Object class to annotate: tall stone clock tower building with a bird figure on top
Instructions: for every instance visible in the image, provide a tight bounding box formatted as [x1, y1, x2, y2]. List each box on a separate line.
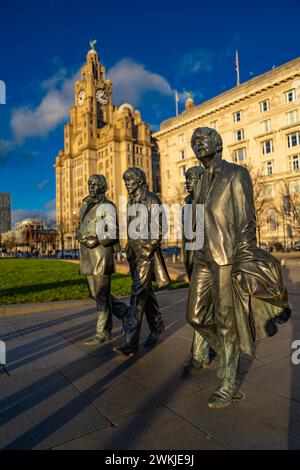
[55, 49, 160, 249]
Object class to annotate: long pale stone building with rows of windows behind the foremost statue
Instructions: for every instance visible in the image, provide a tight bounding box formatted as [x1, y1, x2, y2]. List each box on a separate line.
[154, 59, 300, 246]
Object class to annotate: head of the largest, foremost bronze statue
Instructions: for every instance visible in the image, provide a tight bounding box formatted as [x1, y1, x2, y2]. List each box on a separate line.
[191, 127, 223, 167]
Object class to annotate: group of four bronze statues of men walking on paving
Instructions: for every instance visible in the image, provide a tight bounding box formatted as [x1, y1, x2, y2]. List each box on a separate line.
[78, 127, 291, 408]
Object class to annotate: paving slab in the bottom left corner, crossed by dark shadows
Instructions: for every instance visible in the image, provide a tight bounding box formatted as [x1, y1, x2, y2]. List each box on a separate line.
[0, 368, 110, 449]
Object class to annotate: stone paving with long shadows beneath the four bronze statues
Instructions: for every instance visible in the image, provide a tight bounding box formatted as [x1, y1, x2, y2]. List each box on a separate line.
[0, 264, 300, 450]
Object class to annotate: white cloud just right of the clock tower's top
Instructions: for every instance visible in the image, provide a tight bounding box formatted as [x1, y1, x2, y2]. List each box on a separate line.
[107, 58, 174, 106]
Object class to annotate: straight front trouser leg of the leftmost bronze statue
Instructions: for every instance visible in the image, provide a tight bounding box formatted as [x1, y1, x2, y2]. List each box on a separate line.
[87, 274, 112, 337]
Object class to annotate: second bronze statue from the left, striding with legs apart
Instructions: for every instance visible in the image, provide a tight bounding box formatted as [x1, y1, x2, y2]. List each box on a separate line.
[114, 167, 170, 356]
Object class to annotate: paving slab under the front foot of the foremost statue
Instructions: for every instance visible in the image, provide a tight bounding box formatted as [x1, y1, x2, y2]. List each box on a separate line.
[167, 381, 300, 450]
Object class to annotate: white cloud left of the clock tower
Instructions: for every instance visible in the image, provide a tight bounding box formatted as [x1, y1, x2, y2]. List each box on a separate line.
[11, 69, 78, 144]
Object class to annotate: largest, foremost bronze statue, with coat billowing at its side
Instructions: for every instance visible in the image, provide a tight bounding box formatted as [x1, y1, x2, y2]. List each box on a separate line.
[187, 127, 290, 408]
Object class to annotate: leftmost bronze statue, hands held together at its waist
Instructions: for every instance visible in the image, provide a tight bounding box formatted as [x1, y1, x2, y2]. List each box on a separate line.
[78, 175, 128, 346]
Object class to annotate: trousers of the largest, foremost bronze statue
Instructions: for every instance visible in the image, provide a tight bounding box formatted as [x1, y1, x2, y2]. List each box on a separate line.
[187, 261, 239, 380]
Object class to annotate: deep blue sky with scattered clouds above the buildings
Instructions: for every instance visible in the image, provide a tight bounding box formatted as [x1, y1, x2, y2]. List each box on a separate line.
[0, 0, 300, 226]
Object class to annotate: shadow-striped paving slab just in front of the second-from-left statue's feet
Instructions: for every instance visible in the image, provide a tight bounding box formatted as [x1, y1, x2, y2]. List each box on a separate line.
[60, 353, 198, 423]
